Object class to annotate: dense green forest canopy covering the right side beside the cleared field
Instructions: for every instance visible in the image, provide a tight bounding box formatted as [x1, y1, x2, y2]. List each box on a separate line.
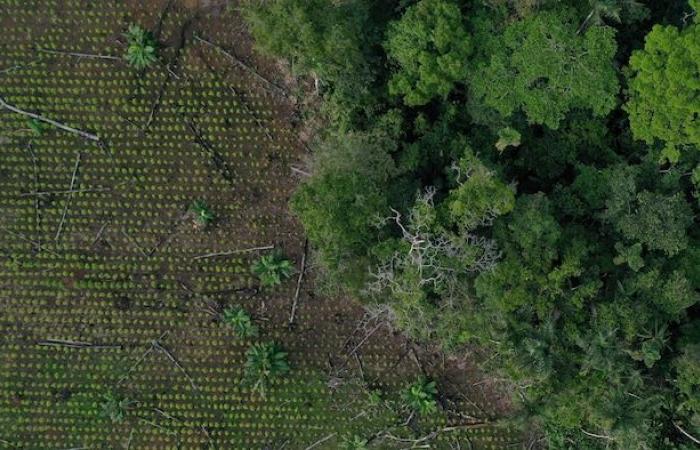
[245, 0, 700, 449]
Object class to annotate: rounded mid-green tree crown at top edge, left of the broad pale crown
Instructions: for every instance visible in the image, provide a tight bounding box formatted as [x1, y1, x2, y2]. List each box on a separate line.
[385, 0, 472, 106]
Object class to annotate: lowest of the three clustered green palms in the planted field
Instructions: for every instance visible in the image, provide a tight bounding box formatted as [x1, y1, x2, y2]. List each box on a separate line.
[244, 342, 289, 397]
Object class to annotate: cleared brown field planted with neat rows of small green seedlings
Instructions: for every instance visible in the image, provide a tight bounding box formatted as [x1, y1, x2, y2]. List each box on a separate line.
[0, 0, 517, 449]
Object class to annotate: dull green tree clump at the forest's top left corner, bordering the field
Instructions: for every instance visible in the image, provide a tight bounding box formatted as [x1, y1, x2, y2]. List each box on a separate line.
[243, 0, 386, 130]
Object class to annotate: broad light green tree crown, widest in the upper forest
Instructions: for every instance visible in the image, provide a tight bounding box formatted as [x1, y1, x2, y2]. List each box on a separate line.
[470, 10, 618, 129]
